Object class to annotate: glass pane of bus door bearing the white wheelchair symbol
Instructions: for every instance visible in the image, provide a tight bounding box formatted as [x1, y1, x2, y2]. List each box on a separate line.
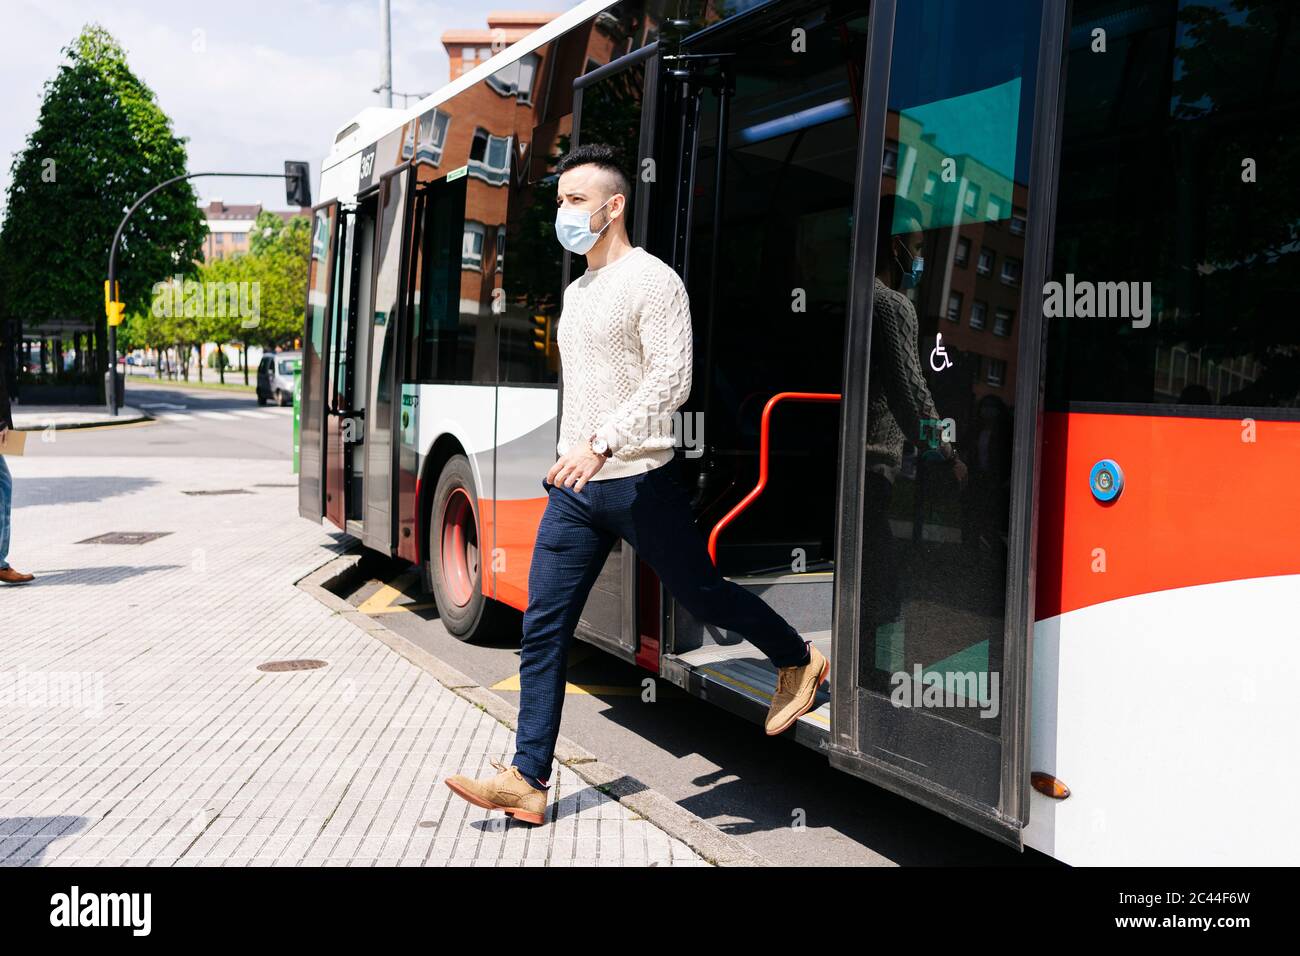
[857, 0, 1041, 754]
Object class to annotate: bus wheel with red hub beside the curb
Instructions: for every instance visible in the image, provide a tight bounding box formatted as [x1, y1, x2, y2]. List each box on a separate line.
[428, 455, 504, 643]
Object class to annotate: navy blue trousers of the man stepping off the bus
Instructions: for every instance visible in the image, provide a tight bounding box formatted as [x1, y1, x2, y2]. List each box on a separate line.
[512, 459, 809, 780]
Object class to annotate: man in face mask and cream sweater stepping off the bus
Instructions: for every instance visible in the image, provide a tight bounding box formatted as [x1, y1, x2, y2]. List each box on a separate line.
[446, 144, 831, 823]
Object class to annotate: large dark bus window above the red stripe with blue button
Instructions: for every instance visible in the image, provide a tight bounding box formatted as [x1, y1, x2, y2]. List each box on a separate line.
[1048, 0, 1300, 418]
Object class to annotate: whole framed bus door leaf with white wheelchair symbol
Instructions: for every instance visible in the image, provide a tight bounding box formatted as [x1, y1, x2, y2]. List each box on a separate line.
[827, 0, 1065, 847]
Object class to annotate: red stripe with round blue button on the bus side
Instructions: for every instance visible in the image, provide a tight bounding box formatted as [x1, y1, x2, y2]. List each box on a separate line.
[1035, 414, 1300, 620]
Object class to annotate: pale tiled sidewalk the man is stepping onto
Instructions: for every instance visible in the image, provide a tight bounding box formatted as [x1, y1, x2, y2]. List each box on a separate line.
[0, 457, 707, 866]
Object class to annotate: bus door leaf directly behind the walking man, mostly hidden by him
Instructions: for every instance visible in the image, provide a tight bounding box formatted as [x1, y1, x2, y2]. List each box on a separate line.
[555, 46, 655, 661]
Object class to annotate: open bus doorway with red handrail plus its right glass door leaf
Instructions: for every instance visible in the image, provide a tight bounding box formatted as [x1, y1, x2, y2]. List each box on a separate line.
[650, 0, 1065, 847]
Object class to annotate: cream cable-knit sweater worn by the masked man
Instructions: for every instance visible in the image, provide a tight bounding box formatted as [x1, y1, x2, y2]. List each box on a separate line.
[555, 246, 693, 481]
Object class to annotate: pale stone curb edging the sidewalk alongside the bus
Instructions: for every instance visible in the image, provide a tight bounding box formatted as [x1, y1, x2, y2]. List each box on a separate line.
[294, 553, 772, 866]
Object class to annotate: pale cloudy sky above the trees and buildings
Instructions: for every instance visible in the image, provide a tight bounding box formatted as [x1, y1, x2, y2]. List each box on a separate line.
[0, 0, 576, 215]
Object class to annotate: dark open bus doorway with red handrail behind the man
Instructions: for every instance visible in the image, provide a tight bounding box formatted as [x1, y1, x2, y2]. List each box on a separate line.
[647, 3, 868, 723]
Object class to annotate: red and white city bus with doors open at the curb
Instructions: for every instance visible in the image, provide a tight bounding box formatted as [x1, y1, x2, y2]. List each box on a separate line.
[299, 0, 1300, 865]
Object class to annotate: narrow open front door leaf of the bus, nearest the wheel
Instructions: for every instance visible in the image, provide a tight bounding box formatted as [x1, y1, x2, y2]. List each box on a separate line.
[354, 165, 411, 554]
